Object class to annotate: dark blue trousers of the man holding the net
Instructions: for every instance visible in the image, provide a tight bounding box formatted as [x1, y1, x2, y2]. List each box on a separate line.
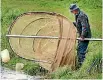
[77, 41, 89, 65]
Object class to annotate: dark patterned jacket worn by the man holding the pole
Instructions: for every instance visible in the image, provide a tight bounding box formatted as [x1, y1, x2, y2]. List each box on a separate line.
[74, 11, 91, 38]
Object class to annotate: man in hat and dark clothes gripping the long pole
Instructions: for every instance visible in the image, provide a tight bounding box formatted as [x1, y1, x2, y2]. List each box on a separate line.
[70, 4, 91, 67]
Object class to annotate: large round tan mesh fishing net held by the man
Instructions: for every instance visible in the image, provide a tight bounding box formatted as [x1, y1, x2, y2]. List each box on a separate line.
[8, 12, 76, 71]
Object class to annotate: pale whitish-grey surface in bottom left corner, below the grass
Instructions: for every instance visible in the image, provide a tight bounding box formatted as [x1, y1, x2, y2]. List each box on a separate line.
[0, 67, 41, 80]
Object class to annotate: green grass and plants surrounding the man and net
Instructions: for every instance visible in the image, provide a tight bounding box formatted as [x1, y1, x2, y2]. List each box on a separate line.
[1, 0, 102, 79]
